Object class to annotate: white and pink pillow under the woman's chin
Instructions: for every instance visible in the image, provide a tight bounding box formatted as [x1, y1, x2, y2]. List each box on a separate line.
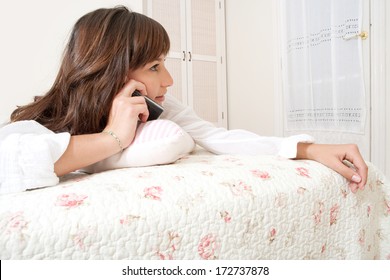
[83, 120, 195, 173]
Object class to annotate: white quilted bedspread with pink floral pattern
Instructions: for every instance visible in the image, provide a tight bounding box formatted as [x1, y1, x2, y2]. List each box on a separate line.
[0, 150, 390, 260]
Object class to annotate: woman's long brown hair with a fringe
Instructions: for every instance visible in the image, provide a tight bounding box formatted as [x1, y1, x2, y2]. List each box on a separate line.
[11, 6, 170, 135]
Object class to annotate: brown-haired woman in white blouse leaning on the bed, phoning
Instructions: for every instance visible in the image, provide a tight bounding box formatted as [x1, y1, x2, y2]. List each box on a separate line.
[0, 7, 367, 192]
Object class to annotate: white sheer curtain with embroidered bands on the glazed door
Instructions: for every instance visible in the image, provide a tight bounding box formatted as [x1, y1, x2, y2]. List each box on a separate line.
[280, 0, 366, 133]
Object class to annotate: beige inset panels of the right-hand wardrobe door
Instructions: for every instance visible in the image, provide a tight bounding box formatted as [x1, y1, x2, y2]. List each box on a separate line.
[187, 0, 219, 124]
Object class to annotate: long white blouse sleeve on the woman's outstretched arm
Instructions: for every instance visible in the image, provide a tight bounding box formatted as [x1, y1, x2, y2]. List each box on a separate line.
[161, 94, 314, 158]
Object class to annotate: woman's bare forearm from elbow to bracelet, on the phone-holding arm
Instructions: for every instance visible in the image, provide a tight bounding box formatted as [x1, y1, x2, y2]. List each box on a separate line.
[54, 133, 121, 176]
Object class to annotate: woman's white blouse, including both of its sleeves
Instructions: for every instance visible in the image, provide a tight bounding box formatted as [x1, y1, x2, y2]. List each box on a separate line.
[0, 94, 313, 194]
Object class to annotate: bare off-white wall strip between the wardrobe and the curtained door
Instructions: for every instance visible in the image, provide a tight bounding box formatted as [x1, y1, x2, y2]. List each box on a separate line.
[225, 0, 275, 135]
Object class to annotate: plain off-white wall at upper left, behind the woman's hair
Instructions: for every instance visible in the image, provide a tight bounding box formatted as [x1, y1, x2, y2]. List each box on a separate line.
[0, 0, 142, 123]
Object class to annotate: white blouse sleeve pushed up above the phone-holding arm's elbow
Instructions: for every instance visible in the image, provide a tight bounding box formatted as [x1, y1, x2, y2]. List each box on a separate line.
[0, 121, 70, 194]
